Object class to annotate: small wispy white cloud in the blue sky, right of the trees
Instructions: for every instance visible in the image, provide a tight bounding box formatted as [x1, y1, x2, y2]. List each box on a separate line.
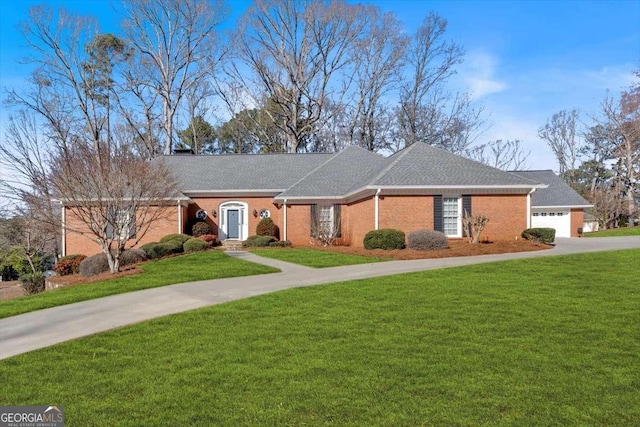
[460, 51, 507, 100]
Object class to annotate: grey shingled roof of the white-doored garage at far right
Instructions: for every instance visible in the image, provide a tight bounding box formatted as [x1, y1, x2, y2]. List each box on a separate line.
[512, 170, 593, 208]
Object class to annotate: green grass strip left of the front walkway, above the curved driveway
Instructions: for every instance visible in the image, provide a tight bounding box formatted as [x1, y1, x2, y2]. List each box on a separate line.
[0, 251, 279, 318]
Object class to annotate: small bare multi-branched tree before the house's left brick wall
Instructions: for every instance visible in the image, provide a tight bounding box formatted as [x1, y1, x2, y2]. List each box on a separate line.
[49, 145, 177, 273]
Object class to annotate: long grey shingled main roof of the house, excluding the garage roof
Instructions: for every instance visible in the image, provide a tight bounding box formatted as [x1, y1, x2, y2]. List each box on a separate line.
[160, 143, 542, 200]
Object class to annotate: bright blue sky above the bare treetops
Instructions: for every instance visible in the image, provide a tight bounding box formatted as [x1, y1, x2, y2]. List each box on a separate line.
[0, 0, 640, 170]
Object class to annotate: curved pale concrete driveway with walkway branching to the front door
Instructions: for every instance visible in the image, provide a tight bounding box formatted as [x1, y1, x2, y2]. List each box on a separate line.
[0, 236, 640, 359]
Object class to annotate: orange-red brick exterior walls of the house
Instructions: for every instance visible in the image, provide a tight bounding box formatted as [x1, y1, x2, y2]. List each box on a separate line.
[65, 194, 536, 255]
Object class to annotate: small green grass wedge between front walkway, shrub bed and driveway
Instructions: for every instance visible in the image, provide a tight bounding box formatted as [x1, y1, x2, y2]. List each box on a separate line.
[251, 248, 390, 268]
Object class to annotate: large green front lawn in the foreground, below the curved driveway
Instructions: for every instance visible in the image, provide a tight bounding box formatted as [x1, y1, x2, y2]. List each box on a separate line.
[0, 250, 640, 426]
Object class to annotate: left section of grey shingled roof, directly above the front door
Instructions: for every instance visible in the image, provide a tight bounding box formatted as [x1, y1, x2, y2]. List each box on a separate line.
[160, 153, 334, 195]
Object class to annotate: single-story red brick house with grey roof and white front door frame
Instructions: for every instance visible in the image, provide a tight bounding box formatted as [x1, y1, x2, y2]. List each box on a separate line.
[63, 143, 588, 255]
